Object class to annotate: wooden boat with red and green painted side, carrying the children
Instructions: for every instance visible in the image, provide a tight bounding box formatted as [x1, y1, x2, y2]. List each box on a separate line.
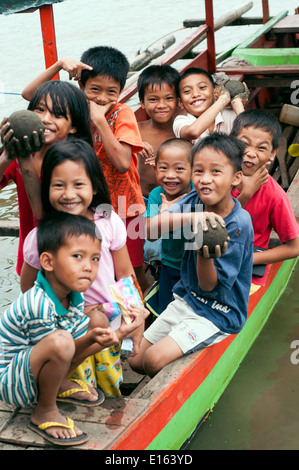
[0, 0, 299, 450]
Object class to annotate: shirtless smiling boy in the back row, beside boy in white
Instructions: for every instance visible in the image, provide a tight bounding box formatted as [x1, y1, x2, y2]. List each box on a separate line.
[137, 64, 180, 198]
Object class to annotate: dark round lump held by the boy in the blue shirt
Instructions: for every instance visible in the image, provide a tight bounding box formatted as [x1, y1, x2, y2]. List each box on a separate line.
[195, 219, 228, 258]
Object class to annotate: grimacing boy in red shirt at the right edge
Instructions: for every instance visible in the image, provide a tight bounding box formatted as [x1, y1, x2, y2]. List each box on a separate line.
[232, 109, 299, 293]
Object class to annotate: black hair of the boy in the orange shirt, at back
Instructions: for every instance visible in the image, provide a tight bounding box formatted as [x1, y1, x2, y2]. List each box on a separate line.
[80, 46, 130, 91]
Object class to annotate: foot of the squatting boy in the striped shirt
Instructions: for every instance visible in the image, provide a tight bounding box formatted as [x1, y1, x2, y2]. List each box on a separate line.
[31, 404, 83, 439]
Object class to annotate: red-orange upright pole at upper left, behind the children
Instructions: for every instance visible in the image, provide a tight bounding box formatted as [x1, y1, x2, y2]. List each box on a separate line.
[39, 5, 59, 80]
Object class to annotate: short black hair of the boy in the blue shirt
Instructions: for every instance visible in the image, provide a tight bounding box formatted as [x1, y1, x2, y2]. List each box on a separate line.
[191, 132, 246, 172]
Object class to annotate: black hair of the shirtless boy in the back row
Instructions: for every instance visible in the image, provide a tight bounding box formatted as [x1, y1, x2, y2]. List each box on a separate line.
[137, 64, 180, 101]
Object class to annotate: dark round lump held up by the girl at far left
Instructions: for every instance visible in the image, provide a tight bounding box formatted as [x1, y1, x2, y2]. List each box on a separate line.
[8, 110, 45, 153]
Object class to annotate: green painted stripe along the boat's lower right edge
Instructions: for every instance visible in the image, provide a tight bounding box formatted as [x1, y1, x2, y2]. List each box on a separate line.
[147, 258, 298, 450]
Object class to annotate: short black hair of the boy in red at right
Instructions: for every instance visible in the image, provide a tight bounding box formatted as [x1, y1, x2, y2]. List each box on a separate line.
[231, 109, 281, 150]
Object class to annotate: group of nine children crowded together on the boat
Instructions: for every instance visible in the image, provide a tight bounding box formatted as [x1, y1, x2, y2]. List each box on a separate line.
[0, 46, 299, 445]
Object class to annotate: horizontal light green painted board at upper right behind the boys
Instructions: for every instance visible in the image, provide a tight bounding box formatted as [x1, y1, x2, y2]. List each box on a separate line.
[232, 47, 299, 65]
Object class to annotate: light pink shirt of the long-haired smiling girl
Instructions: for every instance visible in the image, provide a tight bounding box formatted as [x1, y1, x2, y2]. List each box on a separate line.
[24, 211, 127, 305]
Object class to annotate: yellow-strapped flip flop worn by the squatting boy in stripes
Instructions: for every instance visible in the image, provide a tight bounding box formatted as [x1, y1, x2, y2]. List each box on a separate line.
[28, 416, 88, 446]
